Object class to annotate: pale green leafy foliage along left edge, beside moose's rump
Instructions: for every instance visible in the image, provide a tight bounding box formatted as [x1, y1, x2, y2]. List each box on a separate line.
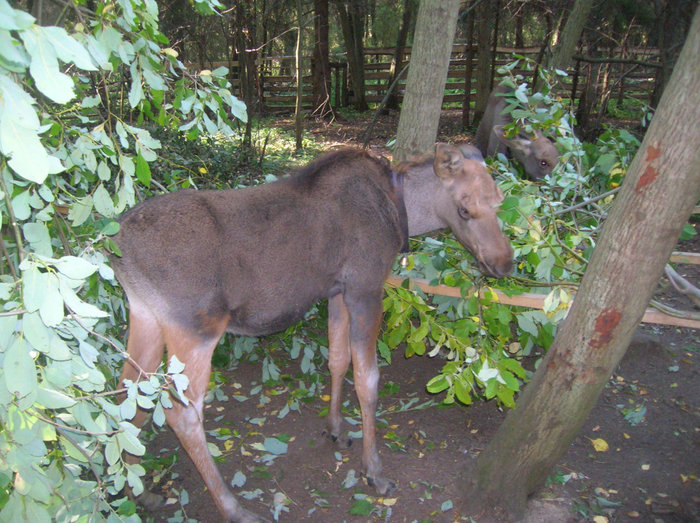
[0, 0, 246, 522]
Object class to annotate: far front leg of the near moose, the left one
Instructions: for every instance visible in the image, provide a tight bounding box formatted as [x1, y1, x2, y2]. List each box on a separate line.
[327, 294, 352, 448]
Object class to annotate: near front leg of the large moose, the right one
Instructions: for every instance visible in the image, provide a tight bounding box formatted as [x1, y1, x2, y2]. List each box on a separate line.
[346, 289, 396, 495]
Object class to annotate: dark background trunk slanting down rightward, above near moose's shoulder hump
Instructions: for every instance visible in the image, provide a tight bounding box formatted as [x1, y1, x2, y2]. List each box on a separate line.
[335, 0, 367, 111]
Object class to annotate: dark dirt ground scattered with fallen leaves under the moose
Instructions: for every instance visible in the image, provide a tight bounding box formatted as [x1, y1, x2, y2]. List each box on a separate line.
[138, 114, 700, 523]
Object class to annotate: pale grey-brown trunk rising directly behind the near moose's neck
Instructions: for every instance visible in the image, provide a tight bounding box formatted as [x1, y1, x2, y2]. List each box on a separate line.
[394, 0, 460, 161]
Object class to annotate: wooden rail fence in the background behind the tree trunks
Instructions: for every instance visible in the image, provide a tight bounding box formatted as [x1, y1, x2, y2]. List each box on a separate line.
[200, 44, 658, 112]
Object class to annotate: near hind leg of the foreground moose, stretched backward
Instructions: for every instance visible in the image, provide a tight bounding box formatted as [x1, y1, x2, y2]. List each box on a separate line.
[165, 323, 265, 523]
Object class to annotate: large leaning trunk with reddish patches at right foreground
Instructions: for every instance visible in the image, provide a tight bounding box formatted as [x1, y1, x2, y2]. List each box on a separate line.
[460, 7, 700, 522]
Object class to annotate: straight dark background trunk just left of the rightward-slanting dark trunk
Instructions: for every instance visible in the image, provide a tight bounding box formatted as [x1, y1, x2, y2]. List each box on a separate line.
[311, 0, 333, 116]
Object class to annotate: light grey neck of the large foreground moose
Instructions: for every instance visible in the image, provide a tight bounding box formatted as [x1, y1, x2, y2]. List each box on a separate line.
[404, 164, 447, 236]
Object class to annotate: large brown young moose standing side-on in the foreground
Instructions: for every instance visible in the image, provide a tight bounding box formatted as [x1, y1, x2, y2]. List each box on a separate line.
[112, 144, 513, 522]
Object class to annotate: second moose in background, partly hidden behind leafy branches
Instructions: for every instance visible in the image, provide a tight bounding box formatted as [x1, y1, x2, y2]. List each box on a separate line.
[476, 85, 559, 180]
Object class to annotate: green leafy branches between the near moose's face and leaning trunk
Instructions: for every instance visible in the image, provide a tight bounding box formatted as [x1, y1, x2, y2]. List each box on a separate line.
[380, 57, 640, 407]
